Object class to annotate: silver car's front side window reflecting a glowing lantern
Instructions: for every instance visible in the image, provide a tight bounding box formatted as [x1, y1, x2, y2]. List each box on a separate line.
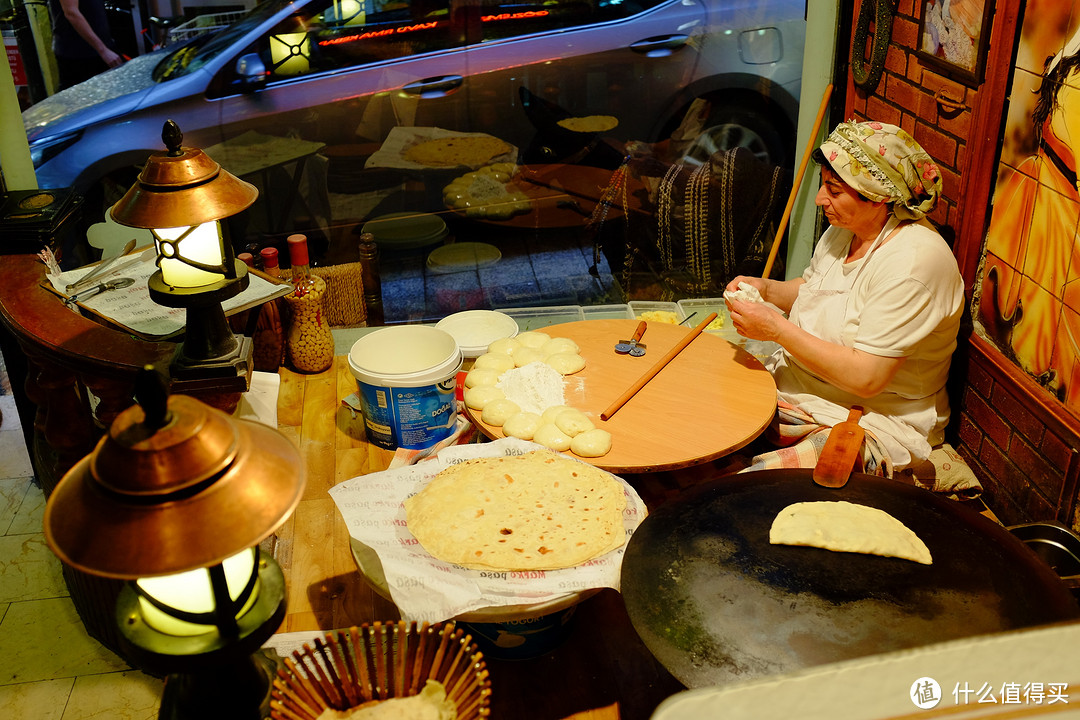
[256, 0, 465, 82]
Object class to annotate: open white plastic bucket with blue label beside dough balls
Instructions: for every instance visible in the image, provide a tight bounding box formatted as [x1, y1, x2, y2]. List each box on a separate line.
[349, 325, 461, 450]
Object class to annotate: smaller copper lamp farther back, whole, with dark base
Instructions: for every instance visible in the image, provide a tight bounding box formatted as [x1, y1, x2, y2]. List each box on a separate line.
[109, 120, 258, 388]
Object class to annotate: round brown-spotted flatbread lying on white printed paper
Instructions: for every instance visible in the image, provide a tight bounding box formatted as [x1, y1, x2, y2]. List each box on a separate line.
[405, 450, 626, 571]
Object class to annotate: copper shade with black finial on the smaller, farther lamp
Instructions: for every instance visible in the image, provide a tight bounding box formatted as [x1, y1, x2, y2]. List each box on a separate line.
[109, 120, 259, 229]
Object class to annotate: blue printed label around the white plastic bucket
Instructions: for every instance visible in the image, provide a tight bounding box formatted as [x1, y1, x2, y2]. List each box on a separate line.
[359, 377, 458, 450]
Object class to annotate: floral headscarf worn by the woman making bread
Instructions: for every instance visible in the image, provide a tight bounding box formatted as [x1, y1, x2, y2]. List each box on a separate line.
[813, 121, 942, 220]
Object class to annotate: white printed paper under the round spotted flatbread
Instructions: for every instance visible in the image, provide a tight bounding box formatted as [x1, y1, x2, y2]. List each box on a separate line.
[329, 437, 647, 623]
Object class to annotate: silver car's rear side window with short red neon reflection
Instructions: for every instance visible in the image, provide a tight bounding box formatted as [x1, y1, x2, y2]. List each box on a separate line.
[481, 0, 663, 41]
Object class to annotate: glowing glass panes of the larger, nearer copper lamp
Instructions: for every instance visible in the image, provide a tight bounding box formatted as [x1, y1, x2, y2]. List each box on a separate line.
[135, 548, 259, 637]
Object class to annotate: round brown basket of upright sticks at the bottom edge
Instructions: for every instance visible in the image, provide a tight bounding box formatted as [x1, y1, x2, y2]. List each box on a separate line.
[270, 621, 491, 720]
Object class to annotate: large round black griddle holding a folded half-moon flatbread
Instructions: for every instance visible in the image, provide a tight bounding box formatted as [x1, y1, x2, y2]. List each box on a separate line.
[622, 470, 1080, 688]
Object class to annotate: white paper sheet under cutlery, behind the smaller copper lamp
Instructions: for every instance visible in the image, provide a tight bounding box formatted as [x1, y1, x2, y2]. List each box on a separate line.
[46, 245, 293, 340]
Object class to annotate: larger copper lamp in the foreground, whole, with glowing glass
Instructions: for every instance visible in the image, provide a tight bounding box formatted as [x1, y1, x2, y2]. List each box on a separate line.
[44, 367, 305, 720]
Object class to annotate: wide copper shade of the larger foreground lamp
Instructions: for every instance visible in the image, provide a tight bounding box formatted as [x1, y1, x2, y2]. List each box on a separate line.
[44, 371, 305, 580]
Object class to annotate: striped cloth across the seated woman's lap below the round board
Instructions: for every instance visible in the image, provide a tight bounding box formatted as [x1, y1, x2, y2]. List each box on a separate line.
[739, 400, 892, 477]
